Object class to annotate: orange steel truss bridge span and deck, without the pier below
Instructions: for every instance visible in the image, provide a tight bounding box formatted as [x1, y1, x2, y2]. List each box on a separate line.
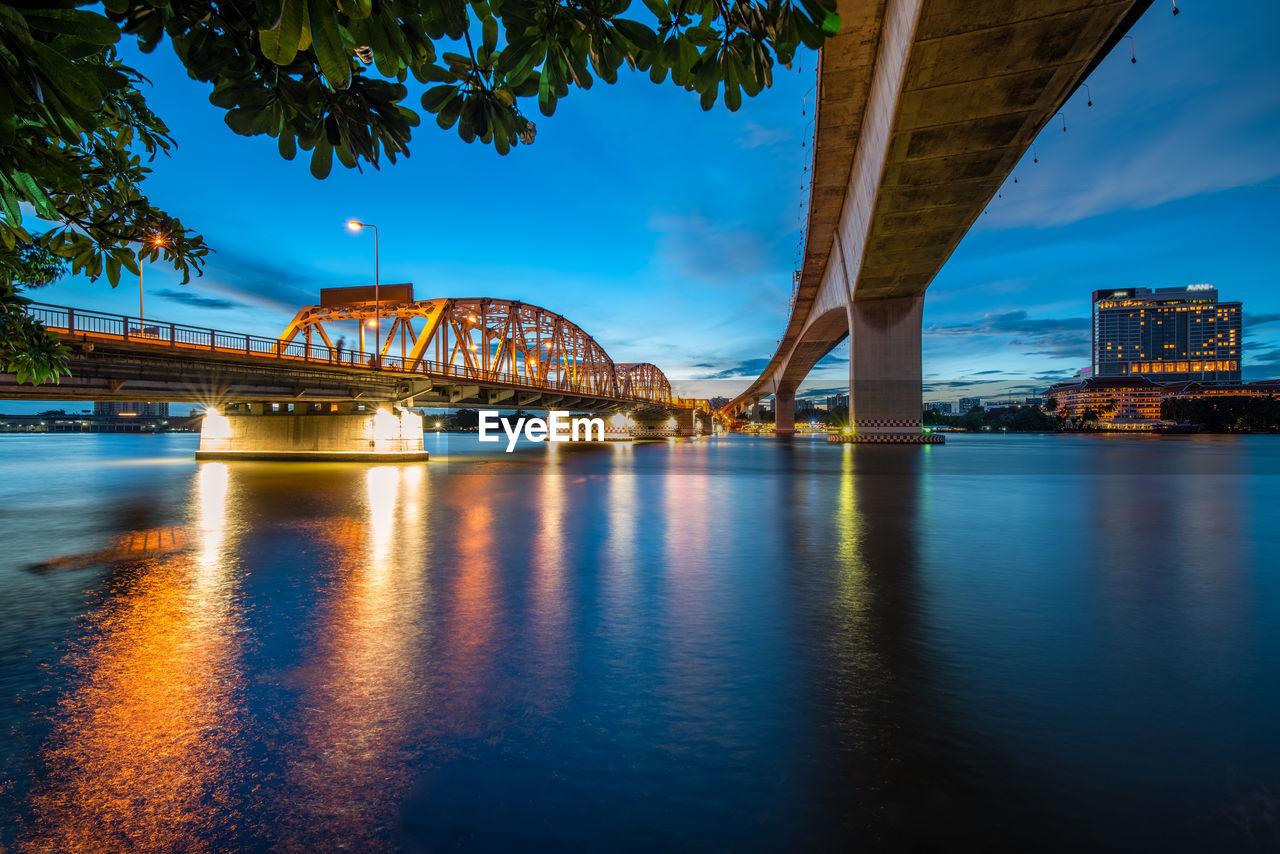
[0, 297, 710, 421]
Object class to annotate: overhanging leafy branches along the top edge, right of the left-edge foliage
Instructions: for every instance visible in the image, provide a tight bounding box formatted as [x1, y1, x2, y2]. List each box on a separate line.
[104, 0, 840, 171]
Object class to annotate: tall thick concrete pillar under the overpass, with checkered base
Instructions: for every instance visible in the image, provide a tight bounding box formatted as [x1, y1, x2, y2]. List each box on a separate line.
[828, 294, 943, 444]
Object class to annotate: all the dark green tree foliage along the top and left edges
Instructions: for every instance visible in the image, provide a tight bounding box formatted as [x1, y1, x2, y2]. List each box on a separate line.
[0, 0, 840, 382]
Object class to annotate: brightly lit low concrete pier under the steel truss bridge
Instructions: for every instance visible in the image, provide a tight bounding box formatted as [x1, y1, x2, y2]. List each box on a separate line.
[196, 405, 428, 462]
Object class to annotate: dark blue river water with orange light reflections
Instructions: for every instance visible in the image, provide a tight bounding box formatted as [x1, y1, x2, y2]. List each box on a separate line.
[0, 435, 1280, 851]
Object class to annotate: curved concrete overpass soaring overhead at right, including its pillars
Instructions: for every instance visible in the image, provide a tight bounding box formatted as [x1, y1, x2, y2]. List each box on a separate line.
[724, 0, 1151, 442]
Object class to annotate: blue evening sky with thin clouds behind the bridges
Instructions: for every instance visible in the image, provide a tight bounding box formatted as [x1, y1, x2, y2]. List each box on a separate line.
[4, 0, 1280, 411]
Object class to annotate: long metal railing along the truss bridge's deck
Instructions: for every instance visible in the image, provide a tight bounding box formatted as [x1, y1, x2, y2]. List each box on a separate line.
[27, 302, 690, 406]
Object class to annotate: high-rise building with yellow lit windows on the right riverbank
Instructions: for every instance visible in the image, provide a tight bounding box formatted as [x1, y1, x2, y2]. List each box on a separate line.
[1093, 284, 1242, 383]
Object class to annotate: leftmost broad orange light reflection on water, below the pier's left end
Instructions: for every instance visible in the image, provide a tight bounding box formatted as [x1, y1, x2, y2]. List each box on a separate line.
[27, 463, 244, 851]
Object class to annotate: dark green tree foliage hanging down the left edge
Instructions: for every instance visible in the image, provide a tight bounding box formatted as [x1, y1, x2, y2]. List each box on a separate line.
[0, 0, 207, 383]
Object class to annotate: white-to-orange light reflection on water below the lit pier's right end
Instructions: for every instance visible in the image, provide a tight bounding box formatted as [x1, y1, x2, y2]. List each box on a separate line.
[280, 466, 434, 850]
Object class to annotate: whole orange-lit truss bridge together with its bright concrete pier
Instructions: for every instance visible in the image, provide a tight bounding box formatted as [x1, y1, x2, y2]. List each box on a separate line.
[0, 299, 714, 458]
